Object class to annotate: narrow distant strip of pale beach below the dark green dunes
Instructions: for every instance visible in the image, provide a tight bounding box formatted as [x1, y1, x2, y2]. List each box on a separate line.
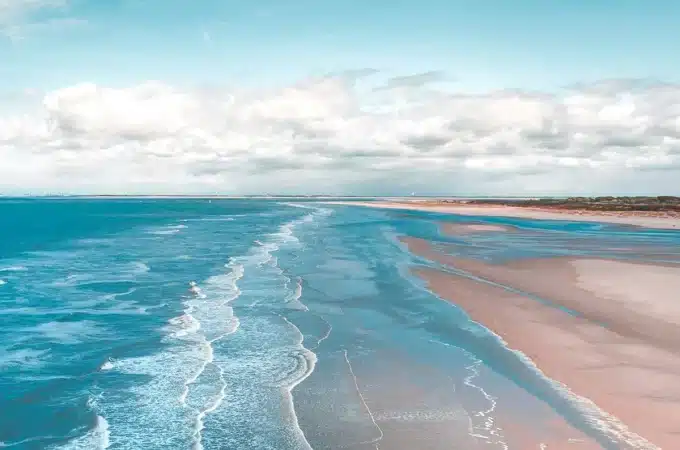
[327, 201, 680, 230]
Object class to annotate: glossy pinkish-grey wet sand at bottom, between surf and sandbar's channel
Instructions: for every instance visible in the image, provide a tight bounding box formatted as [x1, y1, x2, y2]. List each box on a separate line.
[295, 342, 601, 450]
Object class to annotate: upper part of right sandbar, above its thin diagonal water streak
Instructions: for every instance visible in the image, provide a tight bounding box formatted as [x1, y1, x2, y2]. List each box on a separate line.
[408, 239, 680, 352]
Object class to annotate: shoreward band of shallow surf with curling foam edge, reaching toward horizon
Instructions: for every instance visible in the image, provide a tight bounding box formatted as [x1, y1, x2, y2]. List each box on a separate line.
[193, 209, 325, 449]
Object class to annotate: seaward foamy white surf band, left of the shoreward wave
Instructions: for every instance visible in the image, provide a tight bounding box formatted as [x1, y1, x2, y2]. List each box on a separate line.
[93, 261, 244, 450]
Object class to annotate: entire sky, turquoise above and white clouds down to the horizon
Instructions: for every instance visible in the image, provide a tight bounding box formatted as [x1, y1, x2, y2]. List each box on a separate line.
[0, 0, 680, 195]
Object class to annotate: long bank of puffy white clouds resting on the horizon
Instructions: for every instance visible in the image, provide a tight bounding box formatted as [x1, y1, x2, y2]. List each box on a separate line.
[0, 73, 680, 194]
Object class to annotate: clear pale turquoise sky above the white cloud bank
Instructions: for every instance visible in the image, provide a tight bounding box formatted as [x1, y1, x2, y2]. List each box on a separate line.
[0, 0, 680, 90]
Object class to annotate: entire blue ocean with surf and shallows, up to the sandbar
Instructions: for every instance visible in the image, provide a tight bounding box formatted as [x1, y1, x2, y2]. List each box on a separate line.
[0, 198, 676, 450]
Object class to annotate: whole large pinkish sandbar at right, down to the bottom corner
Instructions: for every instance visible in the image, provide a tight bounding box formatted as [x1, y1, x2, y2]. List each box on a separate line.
[404, 239, 680, 449]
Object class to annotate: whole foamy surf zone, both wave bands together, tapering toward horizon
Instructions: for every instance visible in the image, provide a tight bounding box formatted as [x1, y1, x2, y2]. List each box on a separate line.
[82, 205, 330, 450]
